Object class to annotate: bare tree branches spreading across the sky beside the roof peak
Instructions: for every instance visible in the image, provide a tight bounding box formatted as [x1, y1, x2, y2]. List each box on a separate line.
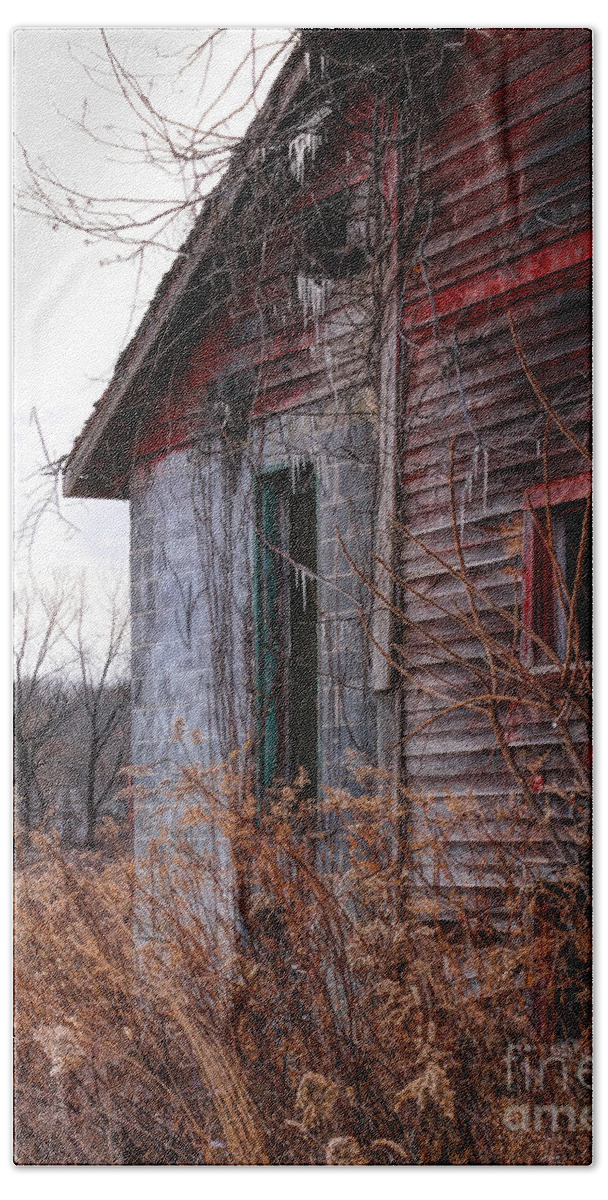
[18, 29, 297, 258]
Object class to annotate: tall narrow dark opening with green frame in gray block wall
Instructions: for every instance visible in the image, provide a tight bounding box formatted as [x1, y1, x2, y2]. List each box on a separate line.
[255, 464, 318, 799]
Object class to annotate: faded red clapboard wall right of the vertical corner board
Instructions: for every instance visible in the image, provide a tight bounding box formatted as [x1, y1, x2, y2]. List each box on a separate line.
[395, 30, 590, 882]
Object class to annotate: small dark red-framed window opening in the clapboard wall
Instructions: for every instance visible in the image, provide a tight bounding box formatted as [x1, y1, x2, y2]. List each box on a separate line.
[524, 480, 591, 662]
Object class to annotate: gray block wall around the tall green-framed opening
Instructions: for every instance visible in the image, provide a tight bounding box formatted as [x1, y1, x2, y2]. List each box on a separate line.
[131, 389, 395, 912]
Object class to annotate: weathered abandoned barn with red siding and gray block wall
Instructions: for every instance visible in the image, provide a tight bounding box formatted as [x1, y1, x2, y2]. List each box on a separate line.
[65, 29, 591, 907]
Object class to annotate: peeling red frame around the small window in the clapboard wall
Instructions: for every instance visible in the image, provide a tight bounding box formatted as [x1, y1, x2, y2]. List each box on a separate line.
[522, 472, 591, 666]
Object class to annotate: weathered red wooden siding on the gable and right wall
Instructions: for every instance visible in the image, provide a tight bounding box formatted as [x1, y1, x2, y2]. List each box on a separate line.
[67, 30, 591, 892]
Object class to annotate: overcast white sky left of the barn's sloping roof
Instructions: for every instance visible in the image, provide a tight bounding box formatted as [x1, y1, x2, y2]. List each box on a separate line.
[14, 28, 288, 628]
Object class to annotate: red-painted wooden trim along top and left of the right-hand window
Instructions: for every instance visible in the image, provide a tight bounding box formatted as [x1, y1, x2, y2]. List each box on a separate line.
[520, 472, 591, 671]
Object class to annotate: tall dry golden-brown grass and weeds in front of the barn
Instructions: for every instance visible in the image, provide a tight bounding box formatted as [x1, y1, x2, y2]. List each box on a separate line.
[16, 758, 590, 1164]
